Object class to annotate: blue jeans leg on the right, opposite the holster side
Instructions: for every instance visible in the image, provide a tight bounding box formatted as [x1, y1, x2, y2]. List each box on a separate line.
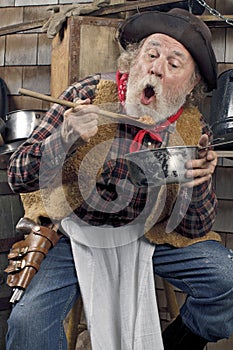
[153, 241, 233, 342]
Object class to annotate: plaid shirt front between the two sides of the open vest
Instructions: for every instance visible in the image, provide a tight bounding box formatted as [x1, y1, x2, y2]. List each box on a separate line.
[73, 124, 149, 227]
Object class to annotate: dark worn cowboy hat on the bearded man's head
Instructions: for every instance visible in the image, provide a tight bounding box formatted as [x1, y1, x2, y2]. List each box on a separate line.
[118, 8, 217, 91]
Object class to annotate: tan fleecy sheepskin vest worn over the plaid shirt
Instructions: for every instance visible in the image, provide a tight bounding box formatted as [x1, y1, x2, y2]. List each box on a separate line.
[21, 80, 220, 247]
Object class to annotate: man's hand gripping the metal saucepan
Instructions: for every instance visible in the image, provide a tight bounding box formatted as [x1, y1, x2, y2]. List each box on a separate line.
[185, 135, 217, 187]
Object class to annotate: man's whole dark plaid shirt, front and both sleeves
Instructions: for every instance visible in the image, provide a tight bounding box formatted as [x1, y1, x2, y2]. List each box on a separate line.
[8, 74, 216, 238]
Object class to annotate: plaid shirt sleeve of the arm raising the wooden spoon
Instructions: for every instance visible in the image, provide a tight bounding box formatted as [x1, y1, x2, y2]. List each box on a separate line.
[8, 74, 100, 193]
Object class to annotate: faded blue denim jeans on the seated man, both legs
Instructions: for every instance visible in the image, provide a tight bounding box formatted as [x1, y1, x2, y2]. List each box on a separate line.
[7, 237, 233, 350]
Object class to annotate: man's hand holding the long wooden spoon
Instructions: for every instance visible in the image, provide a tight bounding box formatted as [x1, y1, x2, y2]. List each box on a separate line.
[61, 99, 98, 148]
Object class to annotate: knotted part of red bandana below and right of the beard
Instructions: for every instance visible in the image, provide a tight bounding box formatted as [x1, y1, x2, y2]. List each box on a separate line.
[130, 107, 183, 152]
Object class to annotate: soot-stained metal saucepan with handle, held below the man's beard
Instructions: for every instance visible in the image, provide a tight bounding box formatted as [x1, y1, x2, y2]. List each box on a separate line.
[125, 140, 233, 187]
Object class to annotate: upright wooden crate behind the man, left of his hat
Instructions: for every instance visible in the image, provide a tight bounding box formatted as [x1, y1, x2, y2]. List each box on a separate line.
[51, 16, 121, 96]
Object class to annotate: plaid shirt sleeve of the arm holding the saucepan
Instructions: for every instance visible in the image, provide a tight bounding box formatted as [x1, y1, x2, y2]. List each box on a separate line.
[176, 115, 217, 238]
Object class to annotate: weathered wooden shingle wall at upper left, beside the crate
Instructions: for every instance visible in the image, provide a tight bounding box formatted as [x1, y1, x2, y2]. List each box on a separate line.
[0, 0, 90, 111]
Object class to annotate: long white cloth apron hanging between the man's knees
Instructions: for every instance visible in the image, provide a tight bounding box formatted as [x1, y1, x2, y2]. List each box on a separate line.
[62, 218, 163, 350]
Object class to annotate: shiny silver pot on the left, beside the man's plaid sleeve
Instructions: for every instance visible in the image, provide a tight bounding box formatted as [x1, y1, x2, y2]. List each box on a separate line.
[4, 110, 46, 143]
